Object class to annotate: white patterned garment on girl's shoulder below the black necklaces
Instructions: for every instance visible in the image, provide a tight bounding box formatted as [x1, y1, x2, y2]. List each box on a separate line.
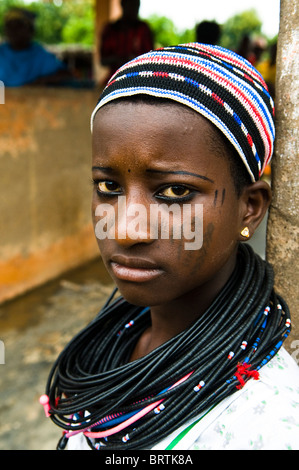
[68, 348, 299, 450]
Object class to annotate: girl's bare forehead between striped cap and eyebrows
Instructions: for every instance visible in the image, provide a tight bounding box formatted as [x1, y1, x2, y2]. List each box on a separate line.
[92, 99, 231, 171]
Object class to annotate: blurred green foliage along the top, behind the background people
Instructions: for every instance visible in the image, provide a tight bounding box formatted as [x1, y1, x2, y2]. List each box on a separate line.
[0, 0, 270, 49]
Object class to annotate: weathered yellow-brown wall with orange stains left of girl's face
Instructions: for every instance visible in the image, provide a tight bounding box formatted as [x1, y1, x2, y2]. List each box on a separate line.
[0, 87, 99, 302]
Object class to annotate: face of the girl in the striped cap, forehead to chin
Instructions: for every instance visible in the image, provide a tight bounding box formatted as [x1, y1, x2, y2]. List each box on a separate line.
[92, 102, 243, 309]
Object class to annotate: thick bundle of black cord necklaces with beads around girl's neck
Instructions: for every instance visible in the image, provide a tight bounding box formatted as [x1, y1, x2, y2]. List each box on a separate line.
[46, 245, 290, 450]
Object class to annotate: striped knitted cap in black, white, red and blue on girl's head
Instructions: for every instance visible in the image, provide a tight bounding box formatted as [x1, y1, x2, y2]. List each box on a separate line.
[91, 43, 275, 181]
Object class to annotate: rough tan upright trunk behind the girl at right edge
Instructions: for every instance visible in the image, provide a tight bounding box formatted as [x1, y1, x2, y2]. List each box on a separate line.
[266, 0, 299, 356]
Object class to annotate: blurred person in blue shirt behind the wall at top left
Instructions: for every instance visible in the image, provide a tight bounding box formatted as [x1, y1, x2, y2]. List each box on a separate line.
[0, 8, 70, 87]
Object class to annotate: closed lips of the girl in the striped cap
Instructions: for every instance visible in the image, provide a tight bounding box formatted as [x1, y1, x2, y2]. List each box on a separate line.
[110, 255, 163, 282]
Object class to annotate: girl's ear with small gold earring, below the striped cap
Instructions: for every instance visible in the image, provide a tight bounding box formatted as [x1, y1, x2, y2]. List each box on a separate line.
[240, 180, 272, 241]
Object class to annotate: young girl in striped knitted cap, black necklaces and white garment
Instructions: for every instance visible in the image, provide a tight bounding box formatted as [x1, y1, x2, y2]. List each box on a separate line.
[43, 43, 299, 450]
